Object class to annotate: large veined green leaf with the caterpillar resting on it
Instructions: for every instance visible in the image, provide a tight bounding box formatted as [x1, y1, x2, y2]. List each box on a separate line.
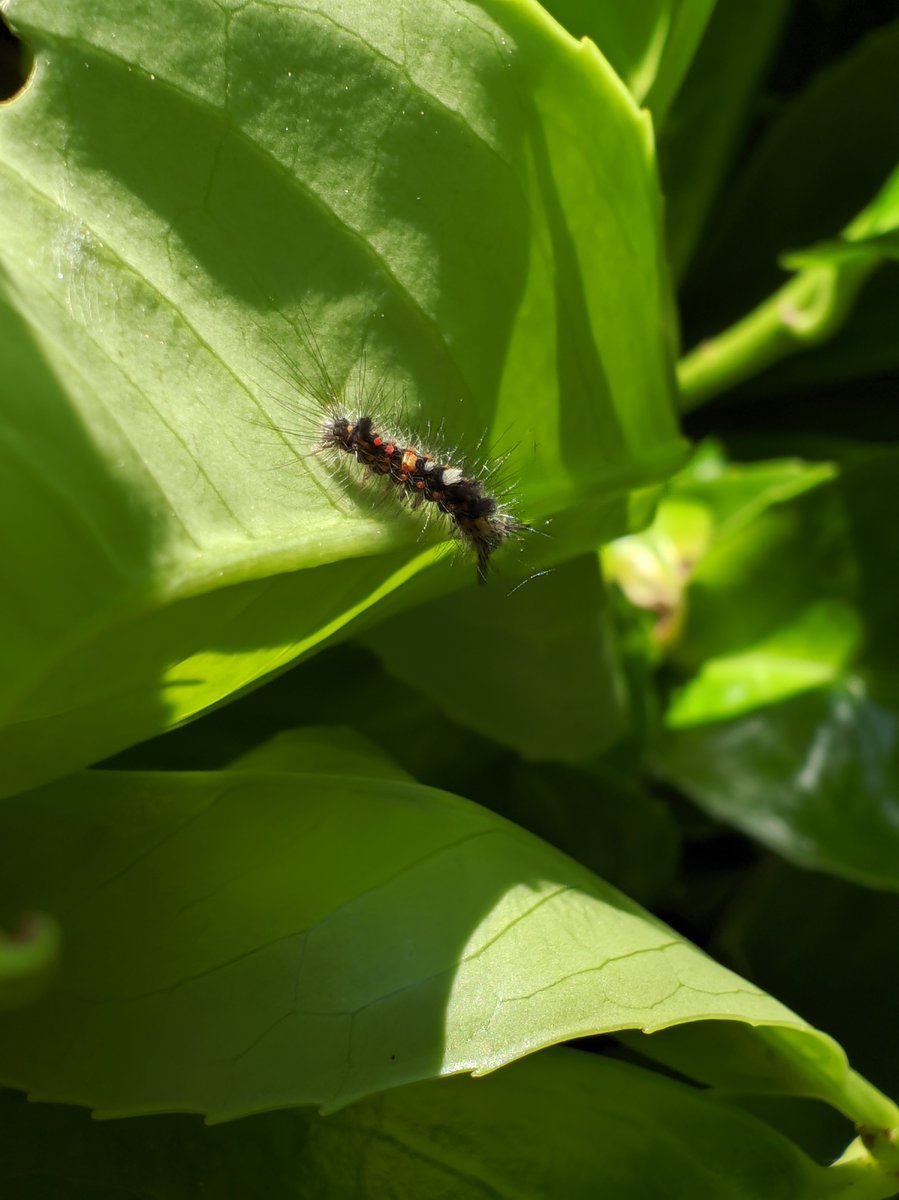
[0, 0, 679, 791]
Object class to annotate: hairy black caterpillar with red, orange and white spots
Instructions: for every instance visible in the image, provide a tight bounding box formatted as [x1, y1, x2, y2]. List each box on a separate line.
[262, 314, 534, 584]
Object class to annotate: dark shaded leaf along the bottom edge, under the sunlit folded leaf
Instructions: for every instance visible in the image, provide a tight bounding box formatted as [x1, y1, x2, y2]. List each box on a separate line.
[0, 1050, 893, 1200]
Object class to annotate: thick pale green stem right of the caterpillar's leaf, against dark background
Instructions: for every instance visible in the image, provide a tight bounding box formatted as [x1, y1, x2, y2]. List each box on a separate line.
[677, 257, 877, 413]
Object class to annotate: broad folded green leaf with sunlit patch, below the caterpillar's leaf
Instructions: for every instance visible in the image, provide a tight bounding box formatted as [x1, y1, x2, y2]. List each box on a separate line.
[0, 762, 889, 1123]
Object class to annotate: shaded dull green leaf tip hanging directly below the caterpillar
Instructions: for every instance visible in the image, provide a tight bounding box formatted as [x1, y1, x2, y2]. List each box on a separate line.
[367, 554, 628, 762]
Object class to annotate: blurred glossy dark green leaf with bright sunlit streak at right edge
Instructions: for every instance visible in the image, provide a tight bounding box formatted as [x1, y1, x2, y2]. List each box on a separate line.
[654, 450, 899, 888]
